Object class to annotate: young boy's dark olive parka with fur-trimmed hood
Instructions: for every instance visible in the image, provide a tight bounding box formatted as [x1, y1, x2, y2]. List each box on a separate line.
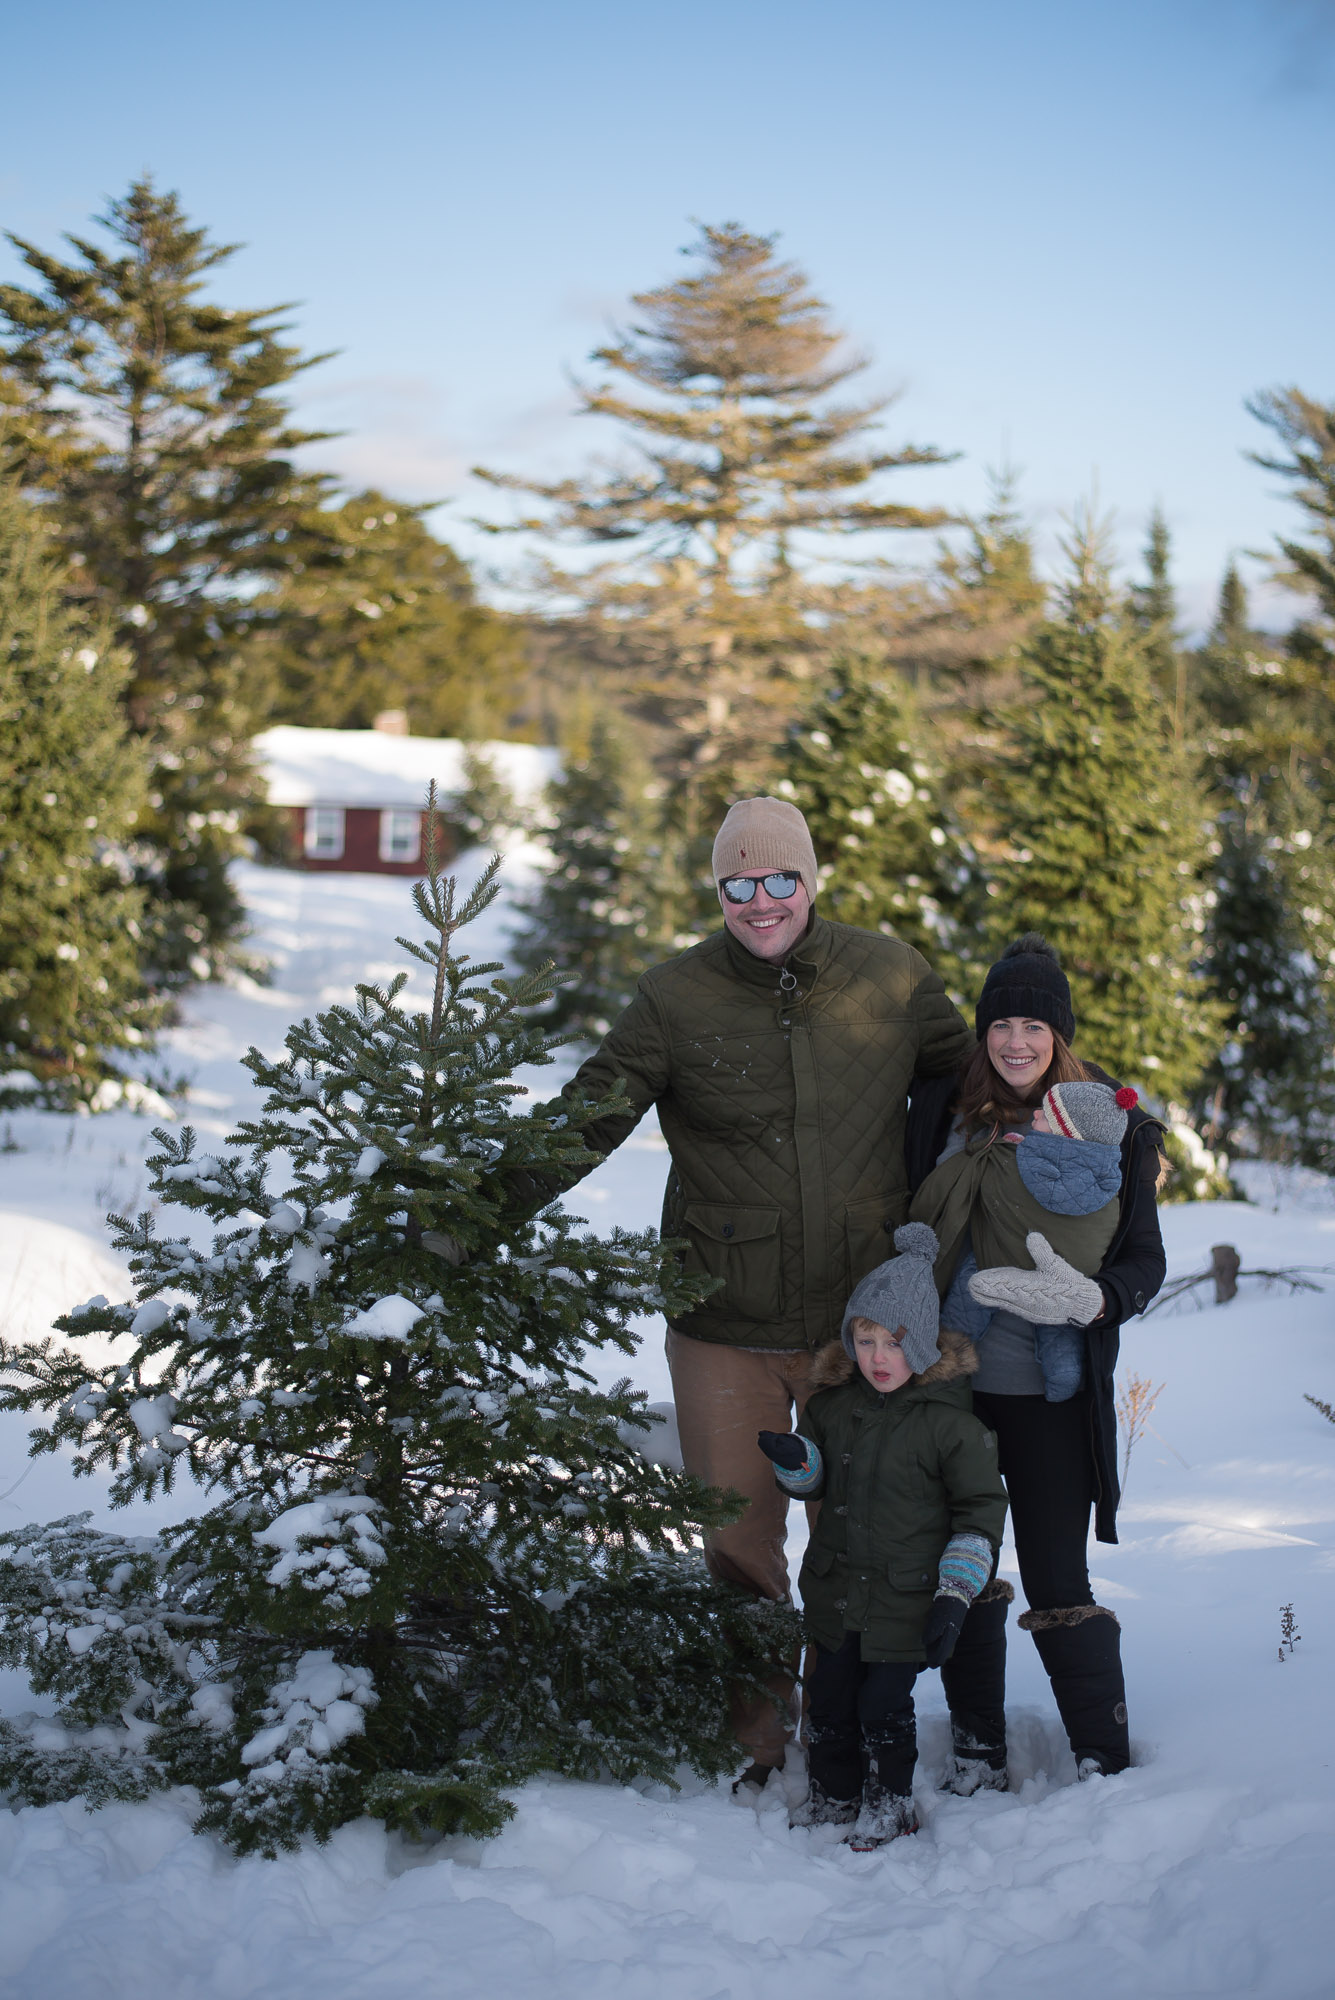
[797, 1328, 1005, 1666]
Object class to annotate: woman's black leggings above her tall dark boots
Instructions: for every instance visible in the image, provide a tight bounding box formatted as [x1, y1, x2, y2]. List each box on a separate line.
[973, 1390, 1093, 1612]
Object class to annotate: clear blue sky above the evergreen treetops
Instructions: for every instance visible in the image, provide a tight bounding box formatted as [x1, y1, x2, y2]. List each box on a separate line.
[0, 0, 1335, 620]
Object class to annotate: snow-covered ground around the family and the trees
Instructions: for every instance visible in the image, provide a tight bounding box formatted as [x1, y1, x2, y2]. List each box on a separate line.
[0, 854, 1335, 2000]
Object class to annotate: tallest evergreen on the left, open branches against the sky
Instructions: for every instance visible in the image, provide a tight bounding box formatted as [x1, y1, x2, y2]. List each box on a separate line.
[0, 178, 333, 980]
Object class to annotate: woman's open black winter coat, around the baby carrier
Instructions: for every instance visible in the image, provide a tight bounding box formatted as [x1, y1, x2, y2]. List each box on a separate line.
[903, 1062, 1167, 1542]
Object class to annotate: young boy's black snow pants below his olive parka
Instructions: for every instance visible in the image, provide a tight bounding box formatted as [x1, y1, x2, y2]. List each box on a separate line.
[805, 1632, 917, 1800]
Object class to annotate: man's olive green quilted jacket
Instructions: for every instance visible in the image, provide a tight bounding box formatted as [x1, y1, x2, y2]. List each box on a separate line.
[547, 916, 973, 1350]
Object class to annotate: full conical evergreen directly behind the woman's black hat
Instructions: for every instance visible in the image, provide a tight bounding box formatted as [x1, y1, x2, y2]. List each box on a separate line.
[989, 498, 1221, 1102]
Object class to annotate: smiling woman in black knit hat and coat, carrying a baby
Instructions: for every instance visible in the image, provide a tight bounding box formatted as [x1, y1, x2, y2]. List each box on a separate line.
[905, 932, 1165, 1794]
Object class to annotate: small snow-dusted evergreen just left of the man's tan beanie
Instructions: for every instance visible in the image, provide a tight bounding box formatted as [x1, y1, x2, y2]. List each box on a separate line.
[516, 716, 679, 1038]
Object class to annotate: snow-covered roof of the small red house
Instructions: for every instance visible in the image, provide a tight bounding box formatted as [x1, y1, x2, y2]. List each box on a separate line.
[256, 724, 560, 806]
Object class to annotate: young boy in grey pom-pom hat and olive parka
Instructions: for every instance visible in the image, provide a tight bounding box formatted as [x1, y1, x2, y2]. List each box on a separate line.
[759, 1222, 1005, 1852]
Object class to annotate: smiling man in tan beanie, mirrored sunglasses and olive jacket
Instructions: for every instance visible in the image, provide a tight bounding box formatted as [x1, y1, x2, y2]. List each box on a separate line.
[543, 798, 973, 1784]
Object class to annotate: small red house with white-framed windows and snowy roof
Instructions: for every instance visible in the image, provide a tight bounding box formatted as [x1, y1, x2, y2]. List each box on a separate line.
[256, 718, 560, 876]
